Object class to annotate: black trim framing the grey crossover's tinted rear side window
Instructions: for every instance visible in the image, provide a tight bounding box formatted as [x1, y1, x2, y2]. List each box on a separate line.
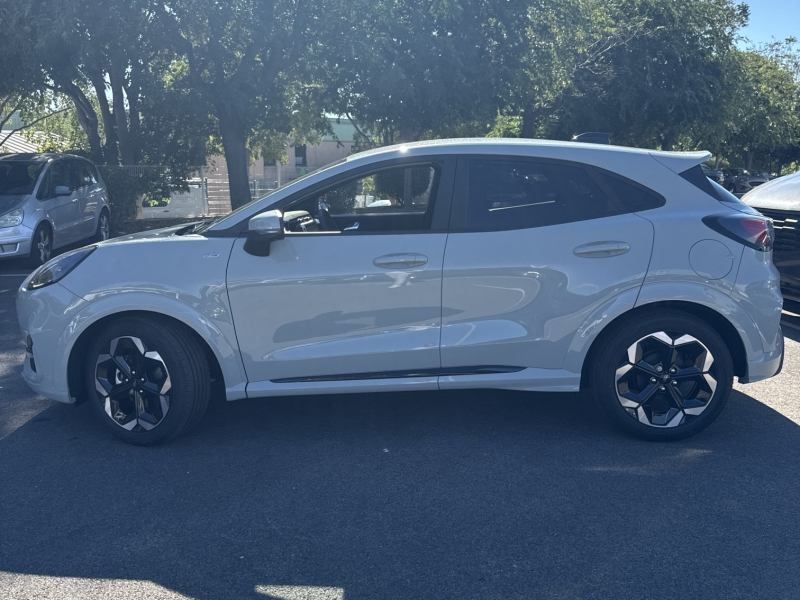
[449, 154, 648, 233]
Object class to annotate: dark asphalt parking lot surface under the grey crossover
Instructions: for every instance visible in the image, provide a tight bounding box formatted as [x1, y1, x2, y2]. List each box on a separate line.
[0, 263, 800, 600]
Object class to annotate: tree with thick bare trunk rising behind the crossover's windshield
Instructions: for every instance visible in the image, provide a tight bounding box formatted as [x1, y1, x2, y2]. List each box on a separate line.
[151, 0, 336, 208]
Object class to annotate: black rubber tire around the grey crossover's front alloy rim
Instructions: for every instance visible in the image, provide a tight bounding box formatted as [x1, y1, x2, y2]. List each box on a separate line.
[84, 317, 208, 446]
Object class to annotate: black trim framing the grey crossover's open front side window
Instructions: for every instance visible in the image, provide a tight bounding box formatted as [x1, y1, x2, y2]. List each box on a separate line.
[208, 154, 457, 237]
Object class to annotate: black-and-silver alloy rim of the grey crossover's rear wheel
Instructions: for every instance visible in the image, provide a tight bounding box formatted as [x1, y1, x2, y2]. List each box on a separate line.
[615, 331, 718, 427]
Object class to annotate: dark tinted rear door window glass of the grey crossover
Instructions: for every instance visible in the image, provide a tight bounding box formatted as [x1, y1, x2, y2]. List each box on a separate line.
[466, 159, 624, 231]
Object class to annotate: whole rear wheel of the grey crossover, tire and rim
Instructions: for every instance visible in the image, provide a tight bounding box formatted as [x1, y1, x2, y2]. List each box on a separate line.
[590, 310, 733, 441]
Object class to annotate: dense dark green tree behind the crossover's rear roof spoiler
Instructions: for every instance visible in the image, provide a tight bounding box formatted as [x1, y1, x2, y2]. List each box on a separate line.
[557, 0, 748, 150]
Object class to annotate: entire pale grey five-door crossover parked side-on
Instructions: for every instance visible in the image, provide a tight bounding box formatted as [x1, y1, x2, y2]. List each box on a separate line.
[17, 139, 783, 445]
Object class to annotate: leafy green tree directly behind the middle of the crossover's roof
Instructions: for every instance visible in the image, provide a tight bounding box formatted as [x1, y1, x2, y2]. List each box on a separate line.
[329, 0, 500, 144]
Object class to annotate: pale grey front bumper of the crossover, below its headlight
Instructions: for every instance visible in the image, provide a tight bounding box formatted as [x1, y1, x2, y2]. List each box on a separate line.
[17, 277, 88, 402]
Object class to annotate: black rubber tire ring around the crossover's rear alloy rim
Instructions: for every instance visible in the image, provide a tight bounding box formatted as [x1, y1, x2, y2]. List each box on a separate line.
[591, 311, 733, 441]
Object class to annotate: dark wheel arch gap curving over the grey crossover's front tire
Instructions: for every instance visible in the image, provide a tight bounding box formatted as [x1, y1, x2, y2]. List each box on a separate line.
[67, 310, 233, 405]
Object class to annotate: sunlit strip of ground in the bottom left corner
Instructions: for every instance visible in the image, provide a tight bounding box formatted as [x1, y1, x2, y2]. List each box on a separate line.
[0, 571, 194, 600]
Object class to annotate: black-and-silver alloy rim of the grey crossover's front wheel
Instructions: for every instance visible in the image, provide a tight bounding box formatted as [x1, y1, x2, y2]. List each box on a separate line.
[95, 336, 172, 431]
